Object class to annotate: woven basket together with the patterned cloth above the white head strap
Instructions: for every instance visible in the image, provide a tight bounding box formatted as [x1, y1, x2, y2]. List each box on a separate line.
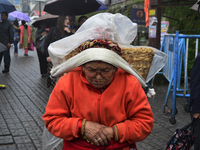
[65, 39, 155, 79]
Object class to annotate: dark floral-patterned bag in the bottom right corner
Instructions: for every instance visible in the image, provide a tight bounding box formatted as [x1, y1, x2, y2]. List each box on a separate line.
[166, 129, 194, 150]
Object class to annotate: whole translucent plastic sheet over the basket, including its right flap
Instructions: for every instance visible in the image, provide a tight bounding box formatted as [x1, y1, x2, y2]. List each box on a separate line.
[48, 13, 167, 86]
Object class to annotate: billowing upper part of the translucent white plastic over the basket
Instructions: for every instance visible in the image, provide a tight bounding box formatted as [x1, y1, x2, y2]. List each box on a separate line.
[48, 13, 137, 67]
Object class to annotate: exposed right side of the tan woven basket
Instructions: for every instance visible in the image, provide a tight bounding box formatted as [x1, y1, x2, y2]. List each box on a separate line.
[121, 47, 155, 80]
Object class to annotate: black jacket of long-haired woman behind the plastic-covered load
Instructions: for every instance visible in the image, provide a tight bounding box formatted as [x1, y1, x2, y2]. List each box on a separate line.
[44, 27, 73, 57]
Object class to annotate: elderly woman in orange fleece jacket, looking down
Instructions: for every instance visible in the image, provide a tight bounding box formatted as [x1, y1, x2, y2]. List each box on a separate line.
[43, 40, 154, 150]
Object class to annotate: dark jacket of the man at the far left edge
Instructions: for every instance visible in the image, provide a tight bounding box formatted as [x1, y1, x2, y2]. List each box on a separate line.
[0, 20, 14, 47]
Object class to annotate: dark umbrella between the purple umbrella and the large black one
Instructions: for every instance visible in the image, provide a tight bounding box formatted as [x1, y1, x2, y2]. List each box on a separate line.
[32, 14, 58, 28]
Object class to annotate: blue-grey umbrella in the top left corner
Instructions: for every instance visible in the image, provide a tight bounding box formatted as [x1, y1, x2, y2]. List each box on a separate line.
[0, 0, 16, 13]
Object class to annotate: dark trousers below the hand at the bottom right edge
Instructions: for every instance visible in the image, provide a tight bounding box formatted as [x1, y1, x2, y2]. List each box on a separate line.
[193, 118, 200, 150]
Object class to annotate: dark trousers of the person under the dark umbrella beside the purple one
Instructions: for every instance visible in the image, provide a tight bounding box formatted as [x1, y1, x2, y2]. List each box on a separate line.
[37, 49, 47, 74]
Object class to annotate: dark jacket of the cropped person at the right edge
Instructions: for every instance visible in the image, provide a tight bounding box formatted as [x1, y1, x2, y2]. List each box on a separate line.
[188, 53, 200, 113]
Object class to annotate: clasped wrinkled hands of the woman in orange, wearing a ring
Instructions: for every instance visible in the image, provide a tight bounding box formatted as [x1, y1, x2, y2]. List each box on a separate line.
[85, 121, 113, 146]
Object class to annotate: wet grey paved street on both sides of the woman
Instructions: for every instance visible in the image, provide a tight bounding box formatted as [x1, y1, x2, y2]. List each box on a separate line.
[0, 47, 193, 150]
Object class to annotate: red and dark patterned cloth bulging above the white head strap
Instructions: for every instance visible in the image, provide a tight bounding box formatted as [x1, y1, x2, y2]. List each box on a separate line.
[77, 39, 122, 55]
